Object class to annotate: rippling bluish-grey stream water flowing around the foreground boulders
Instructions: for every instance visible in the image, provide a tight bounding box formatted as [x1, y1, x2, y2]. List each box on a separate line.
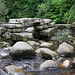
[0, 49, 75, 75]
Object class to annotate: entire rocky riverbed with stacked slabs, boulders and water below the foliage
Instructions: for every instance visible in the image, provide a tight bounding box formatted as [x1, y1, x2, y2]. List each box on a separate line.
[0, 18, 75, 75]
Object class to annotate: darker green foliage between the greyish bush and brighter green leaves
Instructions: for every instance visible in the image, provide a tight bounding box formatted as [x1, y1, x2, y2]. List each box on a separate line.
[7, 0, 42, 19]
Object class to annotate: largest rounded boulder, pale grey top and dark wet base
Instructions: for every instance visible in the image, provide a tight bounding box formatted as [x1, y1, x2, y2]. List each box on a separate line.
[10, 41, 36, 58]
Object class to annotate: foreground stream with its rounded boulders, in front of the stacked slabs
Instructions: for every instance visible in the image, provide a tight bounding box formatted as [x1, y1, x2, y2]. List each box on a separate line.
[0, 41, 75, 75]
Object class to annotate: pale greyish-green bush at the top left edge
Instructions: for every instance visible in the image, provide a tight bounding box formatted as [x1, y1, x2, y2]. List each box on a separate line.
[0, 0, 8, 23]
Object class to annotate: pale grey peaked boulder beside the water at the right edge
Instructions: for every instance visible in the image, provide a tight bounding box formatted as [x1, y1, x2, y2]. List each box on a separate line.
[57, 42, 74, 56]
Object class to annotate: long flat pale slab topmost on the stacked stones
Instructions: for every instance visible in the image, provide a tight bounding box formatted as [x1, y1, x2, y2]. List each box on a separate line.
[9, 18, 44, 27]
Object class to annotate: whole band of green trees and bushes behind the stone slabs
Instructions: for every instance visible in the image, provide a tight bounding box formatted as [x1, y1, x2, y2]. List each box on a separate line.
[0, 0, 75, 23]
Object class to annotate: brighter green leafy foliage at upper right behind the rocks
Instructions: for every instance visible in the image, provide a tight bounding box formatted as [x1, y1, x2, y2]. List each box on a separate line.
[36, 0, 75, 23]
